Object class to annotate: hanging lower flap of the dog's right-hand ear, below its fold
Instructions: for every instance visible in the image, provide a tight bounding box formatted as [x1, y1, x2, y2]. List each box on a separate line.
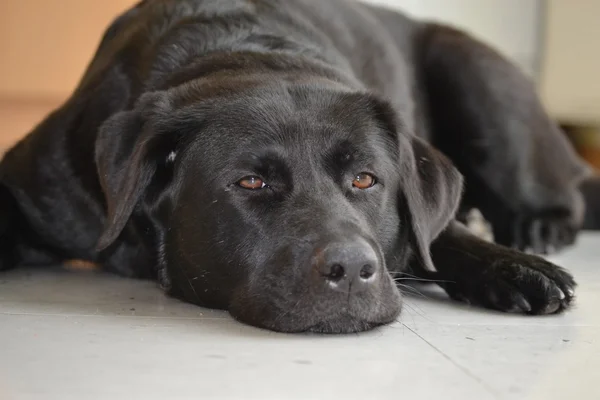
[401, 137, 463, 271]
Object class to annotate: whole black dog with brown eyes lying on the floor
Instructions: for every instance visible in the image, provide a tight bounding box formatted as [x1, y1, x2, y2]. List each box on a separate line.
[0, 0, 599, 332]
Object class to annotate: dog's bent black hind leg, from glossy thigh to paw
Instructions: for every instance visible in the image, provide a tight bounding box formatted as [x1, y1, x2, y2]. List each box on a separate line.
[417, 24, 589, 253]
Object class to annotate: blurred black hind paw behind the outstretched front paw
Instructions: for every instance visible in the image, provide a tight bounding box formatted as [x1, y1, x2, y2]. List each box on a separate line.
[493, 214, 579, 254]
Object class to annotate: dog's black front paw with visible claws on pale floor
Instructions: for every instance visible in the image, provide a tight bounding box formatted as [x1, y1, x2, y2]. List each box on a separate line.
[444, 252, 576, 315]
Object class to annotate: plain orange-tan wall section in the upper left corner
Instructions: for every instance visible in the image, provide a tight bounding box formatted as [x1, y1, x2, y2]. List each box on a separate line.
[0, 0, 136, 99]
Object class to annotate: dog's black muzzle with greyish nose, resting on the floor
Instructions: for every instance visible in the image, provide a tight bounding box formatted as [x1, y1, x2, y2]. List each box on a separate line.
[182, 231, 402, 334]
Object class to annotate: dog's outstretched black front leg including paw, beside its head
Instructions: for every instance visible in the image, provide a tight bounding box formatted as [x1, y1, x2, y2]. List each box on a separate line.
[417, 222, 576, 314]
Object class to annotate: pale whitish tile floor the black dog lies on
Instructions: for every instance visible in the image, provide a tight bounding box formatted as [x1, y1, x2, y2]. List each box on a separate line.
[0, 234, 600, 400]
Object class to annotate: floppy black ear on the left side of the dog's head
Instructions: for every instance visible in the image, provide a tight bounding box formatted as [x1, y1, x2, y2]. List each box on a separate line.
[95, 95, 169, 250]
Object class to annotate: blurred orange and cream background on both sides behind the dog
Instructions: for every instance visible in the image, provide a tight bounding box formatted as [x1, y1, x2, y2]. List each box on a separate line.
[0, 0, 600, 167]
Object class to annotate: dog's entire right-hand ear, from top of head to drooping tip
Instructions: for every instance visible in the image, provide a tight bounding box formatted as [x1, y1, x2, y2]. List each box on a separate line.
[371, 97, 463, 271]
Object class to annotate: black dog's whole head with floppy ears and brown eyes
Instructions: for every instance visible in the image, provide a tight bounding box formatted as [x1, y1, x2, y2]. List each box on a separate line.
[96, 77, 461, 332]
